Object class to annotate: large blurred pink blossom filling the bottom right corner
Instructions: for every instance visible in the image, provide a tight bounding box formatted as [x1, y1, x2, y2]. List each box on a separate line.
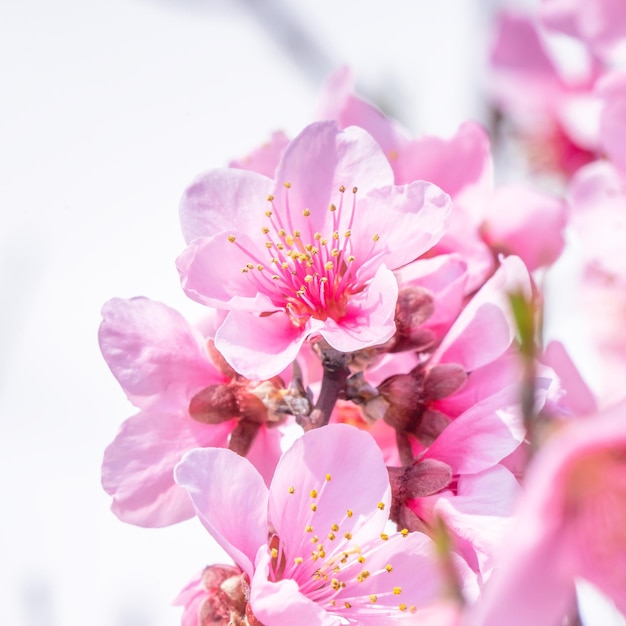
[468, 402, 626, 626]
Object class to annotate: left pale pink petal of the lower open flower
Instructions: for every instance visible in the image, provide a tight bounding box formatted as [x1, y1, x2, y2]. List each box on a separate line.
[174, 448, 267, 577]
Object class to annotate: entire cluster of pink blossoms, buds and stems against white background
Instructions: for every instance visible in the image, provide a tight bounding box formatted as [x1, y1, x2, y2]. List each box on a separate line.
[99, 0, 626, 626]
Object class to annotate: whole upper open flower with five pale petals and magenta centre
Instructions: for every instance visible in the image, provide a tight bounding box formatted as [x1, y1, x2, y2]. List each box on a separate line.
[178, 122, 450, 378]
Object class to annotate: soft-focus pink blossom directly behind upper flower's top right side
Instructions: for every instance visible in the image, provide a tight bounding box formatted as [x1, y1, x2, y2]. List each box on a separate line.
[319, 68, 567, 282]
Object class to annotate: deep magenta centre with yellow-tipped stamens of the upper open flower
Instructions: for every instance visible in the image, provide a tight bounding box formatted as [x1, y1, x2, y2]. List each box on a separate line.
[228, 183, 379, 326]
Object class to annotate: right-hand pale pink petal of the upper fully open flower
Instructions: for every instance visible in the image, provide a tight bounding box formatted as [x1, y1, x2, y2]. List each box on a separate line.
[350, 181, 452, 276]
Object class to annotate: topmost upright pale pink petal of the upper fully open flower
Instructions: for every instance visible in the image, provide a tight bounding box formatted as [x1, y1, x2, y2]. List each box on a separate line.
[273, 122, 393, 236]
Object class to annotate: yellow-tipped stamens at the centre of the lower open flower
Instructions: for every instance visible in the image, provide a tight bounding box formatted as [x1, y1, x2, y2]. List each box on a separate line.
[269, 474, 416, 614]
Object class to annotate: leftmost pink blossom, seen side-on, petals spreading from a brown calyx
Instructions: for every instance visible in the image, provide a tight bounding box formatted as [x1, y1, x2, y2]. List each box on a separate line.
[99, 298, 281, 527]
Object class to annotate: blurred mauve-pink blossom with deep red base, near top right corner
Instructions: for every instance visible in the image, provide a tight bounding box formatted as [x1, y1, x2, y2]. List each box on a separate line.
[490, 11, 601, 176]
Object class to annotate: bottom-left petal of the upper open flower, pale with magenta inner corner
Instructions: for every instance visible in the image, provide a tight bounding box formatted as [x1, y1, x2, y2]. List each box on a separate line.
[215, 310, 315, 380]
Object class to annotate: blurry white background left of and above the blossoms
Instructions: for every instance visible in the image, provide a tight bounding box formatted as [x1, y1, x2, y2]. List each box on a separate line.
[0, 0, 620, 626]
